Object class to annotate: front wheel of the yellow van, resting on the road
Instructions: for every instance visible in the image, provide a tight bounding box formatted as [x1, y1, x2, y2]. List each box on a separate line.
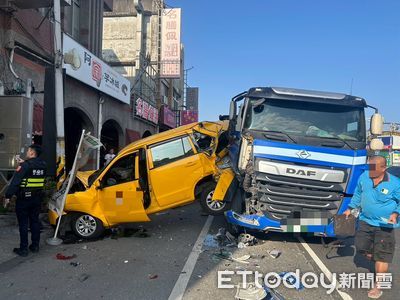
[71, 214, 104, 240]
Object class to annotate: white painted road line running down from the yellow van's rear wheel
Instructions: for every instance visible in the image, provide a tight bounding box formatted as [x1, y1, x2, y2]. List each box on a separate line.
[168, 216, 214, 300]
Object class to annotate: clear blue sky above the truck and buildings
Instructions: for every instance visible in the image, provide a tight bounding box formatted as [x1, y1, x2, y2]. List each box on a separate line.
[166, 0, 400, 122]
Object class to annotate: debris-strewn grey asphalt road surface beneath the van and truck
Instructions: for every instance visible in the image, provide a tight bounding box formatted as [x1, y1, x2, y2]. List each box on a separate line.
[0, 203, 398, 299]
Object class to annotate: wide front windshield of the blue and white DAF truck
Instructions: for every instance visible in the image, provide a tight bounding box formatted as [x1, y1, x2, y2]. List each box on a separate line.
[244, 99, 365, 143]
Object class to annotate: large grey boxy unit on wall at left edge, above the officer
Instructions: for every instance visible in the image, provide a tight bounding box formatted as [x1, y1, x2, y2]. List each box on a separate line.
[0, 96, 33, 170]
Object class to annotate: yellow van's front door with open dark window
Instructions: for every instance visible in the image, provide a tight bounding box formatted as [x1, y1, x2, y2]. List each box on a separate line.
[97, 152, 149, 224]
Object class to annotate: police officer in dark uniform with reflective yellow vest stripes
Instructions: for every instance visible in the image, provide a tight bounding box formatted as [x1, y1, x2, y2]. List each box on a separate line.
[6, 145, 46, 256]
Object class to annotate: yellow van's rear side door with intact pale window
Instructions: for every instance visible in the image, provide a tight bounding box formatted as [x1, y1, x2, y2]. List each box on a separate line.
[149, 136, 203, 207]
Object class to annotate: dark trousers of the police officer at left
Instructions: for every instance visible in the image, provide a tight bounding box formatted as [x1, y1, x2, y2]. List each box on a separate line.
[15, 192, 42, 250]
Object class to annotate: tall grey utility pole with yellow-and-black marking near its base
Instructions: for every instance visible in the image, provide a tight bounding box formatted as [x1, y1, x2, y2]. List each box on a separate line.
[53, 0, 65, 185]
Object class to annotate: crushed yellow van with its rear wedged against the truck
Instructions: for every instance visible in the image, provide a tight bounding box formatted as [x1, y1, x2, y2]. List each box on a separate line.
[49, 122, 229, 239]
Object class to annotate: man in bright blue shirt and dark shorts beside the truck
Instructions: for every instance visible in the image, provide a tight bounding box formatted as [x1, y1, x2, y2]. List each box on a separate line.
[344, 156, 400, 299]
